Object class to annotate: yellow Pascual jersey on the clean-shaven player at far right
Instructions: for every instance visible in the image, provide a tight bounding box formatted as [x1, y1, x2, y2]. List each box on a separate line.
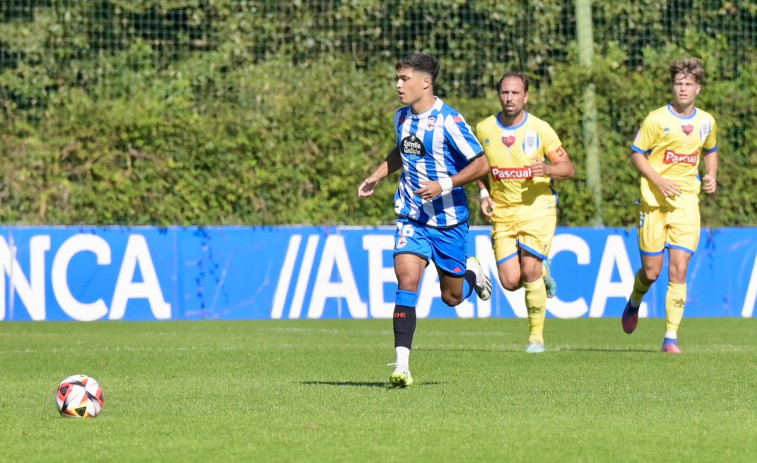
[631, 105, 717, 208]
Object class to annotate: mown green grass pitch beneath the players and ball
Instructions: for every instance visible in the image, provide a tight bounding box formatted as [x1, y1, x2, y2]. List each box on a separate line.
[0, 318, 757, 463]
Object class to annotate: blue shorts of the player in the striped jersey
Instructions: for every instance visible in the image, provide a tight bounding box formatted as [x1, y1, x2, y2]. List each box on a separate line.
[394, 217, 468, 277]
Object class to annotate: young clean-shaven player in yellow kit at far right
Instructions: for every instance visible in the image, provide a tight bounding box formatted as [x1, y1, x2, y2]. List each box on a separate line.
[622, 58, 718, 354]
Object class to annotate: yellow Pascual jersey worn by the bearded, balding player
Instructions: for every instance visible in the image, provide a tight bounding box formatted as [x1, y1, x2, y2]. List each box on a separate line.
[476, 112, 566, 207]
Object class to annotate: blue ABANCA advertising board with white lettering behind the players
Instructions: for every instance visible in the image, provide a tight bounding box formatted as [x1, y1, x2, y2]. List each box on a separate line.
[0, 226, 757, 321]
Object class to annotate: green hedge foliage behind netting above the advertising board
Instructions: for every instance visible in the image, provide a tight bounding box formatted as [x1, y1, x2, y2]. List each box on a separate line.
[0, 0, 757, 227]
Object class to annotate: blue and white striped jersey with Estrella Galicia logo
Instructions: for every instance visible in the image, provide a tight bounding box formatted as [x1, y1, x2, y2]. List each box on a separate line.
[394, 98, 484, 227]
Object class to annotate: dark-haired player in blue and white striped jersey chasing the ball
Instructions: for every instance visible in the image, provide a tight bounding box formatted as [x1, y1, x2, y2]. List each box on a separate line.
[358, 53, 492, 387]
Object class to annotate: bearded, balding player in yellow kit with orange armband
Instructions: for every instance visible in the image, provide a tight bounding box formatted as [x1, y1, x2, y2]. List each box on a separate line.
[476, 72, 575, 353]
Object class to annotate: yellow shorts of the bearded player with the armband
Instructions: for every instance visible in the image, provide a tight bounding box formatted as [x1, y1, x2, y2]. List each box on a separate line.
[492, 206, 557, 264]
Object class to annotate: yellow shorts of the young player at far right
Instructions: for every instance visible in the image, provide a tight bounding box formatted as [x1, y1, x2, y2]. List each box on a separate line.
[637, 203, 701, 256]
